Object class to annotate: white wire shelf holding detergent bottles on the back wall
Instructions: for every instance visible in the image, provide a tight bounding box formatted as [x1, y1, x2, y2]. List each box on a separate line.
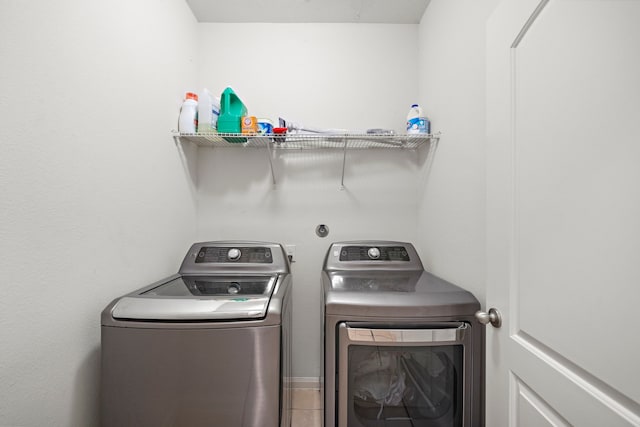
[174, 132, 440, 150]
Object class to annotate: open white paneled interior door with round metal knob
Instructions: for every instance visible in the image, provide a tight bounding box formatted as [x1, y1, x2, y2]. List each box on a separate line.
[487, 0, 640, 427]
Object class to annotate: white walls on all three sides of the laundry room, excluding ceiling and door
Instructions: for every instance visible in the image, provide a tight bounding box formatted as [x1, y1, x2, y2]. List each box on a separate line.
[0, 0, 497, 427]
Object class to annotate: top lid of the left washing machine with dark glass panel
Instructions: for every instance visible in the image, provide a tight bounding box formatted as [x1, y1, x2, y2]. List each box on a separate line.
[112, 275, 278, 321]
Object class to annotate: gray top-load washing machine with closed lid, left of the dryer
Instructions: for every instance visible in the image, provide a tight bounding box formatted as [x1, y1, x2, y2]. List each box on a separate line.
[101, 241, 292, 427]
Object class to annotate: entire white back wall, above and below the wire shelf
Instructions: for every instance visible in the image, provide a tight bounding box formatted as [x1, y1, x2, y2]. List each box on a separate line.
[197, 24, 421, 377]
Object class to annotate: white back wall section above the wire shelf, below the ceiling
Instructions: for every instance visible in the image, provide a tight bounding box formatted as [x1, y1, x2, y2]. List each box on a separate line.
[198, 23, 418, 131]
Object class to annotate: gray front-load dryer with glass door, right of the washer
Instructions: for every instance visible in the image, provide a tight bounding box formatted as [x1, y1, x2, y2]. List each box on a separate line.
[321, 241, 485, 427]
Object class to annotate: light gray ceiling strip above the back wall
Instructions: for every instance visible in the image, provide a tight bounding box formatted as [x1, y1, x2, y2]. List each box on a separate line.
[186, 0, 430, 24]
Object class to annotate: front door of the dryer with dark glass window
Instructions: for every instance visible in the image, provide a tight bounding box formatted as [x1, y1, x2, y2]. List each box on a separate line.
[337, 322, 471, 427]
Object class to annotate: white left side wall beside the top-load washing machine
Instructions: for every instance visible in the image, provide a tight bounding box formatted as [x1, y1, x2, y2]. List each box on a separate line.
[0, 0, 196, 427]
